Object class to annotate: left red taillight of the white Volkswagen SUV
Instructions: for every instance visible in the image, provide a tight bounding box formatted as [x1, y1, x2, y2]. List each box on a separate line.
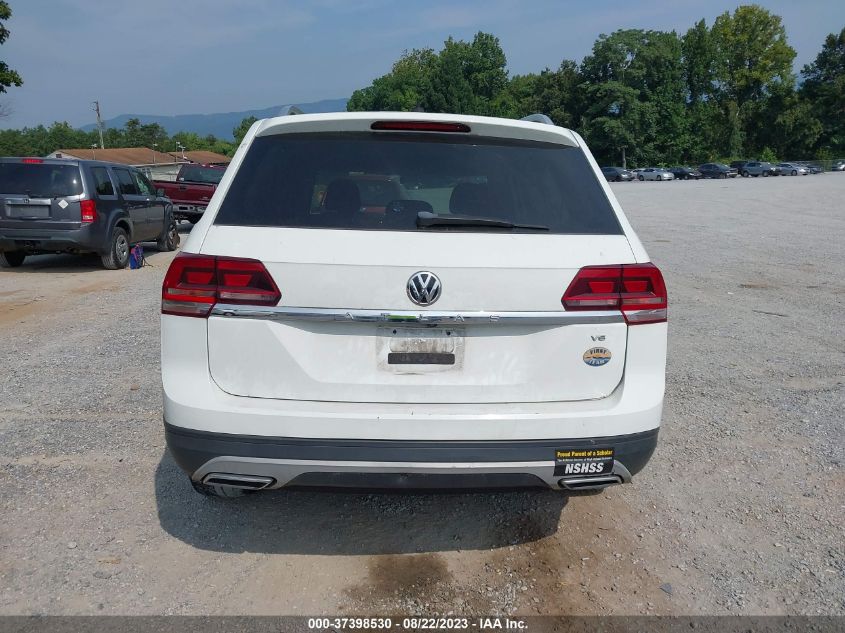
[161, 253, 282, 318]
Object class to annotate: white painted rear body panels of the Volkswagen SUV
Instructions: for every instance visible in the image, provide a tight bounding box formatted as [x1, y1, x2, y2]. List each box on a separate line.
[162, 113, 667, 440]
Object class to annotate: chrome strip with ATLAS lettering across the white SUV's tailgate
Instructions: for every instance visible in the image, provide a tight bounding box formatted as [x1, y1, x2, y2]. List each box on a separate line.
[211, 303, 625, 325]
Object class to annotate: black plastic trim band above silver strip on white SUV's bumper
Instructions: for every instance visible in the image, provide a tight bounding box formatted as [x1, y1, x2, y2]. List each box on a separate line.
[164, 422, 659, 475]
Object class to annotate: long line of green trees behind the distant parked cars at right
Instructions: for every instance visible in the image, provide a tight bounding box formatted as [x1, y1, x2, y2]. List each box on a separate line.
[347, 5, 845, 166]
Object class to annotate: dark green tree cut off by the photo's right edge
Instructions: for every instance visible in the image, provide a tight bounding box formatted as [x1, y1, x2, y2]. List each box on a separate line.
[800, 28, 845, 153]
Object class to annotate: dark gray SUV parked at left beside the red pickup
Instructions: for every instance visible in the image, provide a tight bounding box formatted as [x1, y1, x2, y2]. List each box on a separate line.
[0, 158, 179, 270]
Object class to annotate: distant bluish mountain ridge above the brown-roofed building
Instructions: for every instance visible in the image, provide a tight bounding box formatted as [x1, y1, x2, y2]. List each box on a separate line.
[82, 99, 347, 140]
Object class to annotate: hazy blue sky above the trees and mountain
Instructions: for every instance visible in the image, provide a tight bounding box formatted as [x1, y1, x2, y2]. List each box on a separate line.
[0, 0, 845, 128]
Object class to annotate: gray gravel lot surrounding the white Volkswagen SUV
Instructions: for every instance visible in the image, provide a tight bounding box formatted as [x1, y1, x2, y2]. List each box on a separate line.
[0, 174, 845, 615]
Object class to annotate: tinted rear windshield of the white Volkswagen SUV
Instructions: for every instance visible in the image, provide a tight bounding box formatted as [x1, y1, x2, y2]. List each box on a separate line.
[215, 133, 622, 234]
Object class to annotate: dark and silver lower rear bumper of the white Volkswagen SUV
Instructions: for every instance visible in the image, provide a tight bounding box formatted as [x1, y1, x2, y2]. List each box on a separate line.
[165, 422, 658, 489]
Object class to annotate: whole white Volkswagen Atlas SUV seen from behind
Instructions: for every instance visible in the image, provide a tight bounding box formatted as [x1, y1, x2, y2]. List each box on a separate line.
[161, 112, 667, 496]
